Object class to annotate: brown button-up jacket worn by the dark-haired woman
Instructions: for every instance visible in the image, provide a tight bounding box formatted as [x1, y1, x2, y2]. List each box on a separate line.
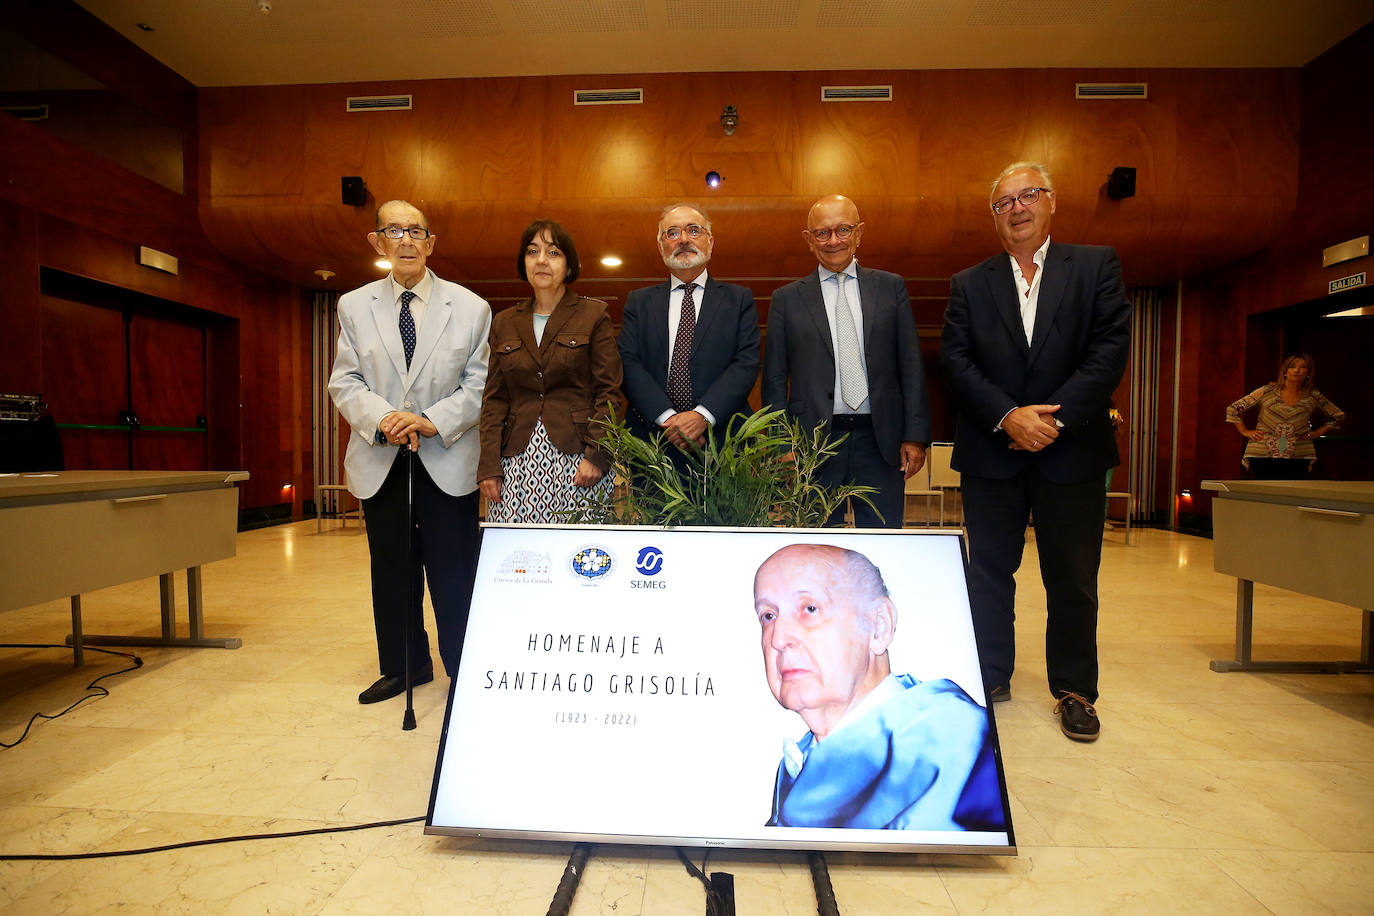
[477, 291, 625, 481]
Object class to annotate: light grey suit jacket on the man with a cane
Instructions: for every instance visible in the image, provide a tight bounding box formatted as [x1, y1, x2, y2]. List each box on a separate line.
[330, 271, 492, 499]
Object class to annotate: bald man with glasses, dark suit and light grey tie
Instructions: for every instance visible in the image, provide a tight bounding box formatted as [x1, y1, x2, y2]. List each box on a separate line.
[763, 195, 930, 527]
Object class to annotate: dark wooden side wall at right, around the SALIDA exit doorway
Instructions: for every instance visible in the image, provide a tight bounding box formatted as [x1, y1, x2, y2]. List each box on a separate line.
[1179, 26, 1374, 529]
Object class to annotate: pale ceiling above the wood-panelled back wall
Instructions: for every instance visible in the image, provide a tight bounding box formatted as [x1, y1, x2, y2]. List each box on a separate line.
[78, 0, 1374, 87]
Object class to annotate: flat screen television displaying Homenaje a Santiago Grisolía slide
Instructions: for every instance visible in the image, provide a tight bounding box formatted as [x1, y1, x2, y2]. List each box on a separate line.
[425, 525, 1015, 854]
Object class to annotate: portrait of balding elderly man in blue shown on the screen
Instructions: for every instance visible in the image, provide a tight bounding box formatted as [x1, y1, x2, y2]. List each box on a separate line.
[754, 544, 1006, 831]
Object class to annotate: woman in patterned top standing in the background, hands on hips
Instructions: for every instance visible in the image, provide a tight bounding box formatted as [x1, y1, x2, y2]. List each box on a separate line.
[1226, 353, 1345, 468]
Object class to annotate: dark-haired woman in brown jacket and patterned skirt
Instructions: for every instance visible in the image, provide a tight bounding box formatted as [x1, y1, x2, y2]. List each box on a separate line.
[477, 220, 625, 523]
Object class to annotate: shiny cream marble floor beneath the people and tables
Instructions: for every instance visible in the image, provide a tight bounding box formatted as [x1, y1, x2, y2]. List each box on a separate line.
[0, 520, 1374, 916]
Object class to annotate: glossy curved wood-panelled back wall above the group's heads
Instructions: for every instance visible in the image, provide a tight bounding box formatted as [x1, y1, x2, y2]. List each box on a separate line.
[201, 70, 1300, 299]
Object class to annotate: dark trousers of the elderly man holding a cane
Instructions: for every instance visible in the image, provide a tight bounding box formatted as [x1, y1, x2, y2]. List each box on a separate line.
[363, 450, 478, 677]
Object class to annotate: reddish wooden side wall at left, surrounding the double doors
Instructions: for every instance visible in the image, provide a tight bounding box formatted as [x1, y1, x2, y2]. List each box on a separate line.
[0, 117, 313, 516]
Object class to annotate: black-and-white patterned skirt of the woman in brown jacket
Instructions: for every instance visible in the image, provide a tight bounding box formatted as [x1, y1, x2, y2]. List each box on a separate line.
[486, 420, 616, 525]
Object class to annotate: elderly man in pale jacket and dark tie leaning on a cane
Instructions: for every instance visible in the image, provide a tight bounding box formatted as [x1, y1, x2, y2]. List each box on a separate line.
[330, 201, 492, 703]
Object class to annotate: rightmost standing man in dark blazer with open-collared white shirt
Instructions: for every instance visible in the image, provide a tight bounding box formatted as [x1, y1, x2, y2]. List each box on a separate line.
[940, 162, 1131, 742]
